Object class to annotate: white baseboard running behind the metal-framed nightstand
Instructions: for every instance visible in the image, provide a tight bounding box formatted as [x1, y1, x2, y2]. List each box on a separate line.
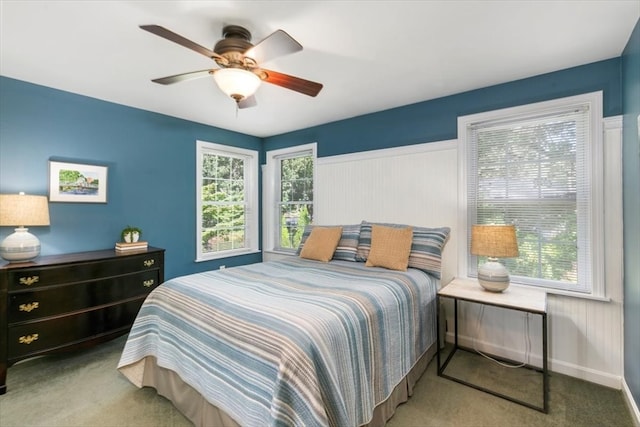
[447, 332, 622, 390]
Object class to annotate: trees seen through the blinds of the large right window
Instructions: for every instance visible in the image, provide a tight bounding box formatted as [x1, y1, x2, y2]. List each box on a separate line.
[476, 117, 582, 284]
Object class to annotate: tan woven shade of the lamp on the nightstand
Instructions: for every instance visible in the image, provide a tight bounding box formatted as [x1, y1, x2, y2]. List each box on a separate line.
[471, 225, 518, 258]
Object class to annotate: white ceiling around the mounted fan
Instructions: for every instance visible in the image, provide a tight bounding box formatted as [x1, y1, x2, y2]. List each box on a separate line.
[0, 0, 640, 137]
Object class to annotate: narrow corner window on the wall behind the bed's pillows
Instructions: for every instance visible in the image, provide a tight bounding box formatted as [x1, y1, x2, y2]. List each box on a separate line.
[265, 144, 316, 252]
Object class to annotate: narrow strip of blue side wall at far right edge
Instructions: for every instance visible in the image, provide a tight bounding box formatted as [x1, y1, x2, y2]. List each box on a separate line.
[622, 20, 640, 407]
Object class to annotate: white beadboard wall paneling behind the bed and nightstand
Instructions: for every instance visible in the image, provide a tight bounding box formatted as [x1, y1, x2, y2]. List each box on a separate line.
[315, 118, 623, 389]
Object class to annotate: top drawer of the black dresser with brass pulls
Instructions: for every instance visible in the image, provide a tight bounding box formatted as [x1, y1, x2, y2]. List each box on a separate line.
[7, 252, 163, 292]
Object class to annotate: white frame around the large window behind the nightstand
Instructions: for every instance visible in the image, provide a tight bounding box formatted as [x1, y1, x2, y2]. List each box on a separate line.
[458, 91, 606, 299]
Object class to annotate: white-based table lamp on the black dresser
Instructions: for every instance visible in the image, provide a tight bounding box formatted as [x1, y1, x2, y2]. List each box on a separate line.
[0, 193, 49, 262]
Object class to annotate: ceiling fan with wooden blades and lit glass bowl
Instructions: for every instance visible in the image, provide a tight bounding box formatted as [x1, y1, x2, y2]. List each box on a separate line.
[140, 25, 322, 108]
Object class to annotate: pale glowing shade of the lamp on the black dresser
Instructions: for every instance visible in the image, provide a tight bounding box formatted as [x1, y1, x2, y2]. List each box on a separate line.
[0, 194, 49, 226]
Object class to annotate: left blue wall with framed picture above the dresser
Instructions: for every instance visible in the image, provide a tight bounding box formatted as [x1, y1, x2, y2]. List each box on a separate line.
[0, 77, 262, 278]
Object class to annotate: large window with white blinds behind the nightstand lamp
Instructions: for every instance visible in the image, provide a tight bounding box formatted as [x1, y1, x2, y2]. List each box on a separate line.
[458, 92, 604, 296]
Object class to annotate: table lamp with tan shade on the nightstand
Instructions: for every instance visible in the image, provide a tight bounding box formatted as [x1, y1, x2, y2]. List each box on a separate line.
[471, 225, 518, 292]
